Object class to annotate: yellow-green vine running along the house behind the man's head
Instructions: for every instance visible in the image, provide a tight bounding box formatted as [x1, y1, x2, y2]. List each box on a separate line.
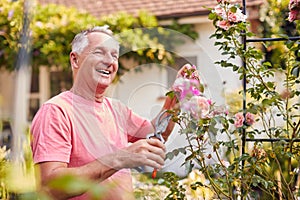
[0, 0, 196, 74]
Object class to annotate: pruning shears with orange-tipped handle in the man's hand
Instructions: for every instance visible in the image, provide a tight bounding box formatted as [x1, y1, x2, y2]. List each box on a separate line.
[147, 110, 172, 178]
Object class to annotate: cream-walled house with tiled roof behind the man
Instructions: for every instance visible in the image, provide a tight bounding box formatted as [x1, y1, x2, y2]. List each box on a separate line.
[0, 0, 262, 175]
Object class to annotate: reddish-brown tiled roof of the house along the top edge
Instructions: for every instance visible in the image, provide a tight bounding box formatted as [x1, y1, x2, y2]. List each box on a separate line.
[39, 0, 262, 19]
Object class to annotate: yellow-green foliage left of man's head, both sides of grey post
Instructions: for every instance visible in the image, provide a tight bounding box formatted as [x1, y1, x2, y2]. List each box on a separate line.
[0, 0, 98, 70]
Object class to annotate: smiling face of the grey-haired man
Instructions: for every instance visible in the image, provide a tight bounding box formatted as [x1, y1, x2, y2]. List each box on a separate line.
[75, 32, 119, 92]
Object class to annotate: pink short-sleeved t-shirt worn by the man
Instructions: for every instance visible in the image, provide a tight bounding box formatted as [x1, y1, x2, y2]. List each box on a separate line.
[31, 91, 153, 200]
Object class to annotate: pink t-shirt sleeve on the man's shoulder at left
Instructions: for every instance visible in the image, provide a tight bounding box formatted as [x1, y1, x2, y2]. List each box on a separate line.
[31, 104, 72, 163]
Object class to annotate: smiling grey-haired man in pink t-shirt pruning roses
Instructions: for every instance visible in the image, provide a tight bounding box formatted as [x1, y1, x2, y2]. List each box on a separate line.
[31, 26, 191, 200]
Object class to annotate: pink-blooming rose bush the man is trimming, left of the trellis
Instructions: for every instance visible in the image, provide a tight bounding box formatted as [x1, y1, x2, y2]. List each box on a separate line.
[163, 64, 254, 198]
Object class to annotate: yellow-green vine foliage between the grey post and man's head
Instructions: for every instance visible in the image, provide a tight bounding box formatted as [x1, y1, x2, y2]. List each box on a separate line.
[31, 4, 99, 69]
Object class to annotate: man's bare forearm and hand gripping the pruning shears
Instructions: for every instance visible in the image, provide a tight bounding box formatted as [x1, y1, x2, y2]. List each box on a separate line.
[38, 139, 165, 199]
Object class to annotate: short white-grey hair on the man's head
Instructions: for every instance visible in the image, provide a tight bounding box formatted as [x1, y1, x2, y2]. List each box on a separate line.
[71, 25, 113, 54]
